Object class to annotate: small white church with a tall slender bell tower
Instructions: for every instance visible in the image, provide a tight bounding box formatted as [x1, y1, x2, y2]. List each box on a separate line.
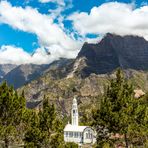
[64, 98, 96, 144]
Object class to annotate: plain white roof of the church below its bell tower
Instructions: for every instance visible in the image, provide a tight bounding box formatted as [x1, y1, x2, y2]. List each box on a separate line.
[64, 124, 88, 132]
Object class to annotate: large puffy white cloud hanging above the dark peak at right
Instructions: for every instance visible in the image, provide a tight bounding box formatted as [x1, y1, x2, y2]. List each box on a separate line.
[68, 2, 148, 39]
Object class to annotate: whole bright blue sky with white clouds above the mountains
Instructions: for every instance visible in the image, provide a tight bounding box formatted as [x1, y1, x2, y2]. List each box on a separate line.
[0, 0, 148, 64]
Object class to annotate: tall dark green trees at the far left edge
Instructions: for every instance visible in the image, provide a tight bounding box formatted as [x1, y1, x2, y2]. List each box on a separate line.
[0, 82, 25, 147]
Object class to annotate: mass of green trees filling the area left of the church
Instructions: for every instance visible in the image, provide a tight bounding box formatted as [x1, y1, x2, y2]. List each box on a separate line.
[0, 82, 77, 148]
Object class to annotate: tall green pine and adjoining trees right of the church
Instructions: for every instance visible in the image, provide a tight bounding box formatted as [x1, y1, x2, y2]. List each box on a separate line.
[93, 70, 148, 148]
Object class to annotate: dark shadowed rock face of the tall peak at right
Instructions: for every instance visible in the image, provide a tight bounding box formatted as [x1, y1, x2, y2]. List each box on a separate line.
[75, 33, 148, 77]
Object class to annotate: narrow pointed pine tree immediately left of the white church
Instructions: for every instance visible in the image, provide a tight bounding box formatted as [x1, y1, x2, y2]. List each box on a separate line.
[39, 97, 63, 148]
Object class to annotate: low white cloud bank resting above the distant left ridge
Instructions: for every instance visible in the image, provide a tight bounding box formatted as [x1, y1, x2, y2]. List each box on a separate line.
[0, 46, 54, 65]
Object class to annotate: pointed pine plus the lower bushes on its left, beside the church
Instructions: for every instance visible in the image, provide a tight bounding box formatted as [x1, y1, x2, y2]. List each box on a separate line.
[24, 98, 64, 148]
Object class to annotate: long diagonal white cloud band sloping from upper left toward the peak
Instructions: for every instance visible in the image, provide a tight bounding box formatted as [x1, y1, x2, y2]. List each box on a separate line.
[0, 1, 80, 64]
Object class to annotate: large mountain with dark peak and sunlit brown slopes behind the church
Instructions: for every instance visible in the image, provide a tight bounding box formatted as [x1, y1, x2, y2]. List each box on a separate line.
[18, 34, 148, 114]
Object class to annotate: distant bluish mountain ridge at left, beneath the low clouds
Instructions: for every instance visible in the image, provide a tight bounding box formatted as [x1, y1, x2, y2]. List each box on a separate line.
[0, 58, 71, 89]
